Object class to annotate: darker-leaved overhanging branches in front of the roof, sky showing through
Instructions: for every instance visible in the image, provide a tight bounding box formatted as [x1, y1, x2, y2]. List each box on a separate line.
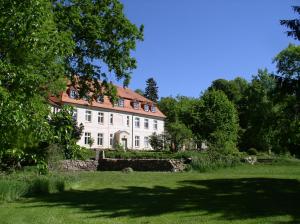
[53, 0, 143, 100]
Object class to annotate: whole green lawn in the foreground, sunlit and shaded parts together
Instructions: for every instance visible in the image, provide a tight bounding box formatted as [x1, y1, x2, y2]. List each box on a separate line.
[0, 164, 300, 224]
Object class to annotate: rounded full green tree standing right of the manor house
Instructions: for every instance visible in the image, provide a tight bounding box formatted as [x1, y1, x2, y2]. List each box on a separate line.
[191, 90, 239, 153]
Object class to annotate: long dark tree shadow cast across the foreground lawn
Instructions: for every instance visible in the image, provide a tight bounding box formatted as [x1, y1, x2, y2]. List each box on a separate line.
[25, 178, 300, 223]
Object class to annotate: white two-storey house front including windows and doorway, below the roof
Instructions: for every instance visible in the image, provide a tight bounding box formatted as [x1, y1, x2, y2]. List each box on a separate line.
[73, 105, 164, 150]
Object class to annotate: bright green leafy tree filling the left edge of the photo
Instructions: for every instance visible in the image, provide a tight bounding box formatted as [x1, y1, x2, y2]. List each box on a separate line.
[0, 0, 72, 168]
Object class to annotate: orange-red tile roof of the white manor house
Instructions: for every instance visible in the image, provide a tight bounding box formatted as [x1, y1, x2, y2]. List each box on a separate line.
[49, 86, 166, 118]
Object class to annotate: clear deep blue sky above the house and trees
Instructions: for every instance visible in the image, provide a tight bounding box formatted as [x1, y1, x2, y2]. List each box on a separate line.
[121, 0, 300, 97]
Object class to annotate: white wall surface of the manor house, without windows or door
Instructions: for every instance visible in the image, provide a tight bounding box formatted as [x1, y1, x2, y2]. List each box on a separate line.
[73, 105, 164, 150]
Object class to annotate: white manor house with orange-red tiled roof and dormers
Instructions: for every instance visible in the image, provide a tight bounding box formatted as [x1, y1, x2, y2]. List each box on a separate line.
[49, 83, 165, 150]
